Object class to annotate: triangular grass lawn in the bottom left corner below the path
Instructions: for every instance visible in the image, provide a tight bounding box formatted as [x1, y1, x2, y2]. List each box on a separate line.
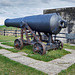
[0, 55, 47, 75]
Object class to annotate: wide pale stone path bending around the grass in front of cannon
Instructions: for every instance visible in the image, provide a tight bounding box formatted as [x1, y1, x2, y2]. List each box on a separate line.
[0, 49, 75, 75]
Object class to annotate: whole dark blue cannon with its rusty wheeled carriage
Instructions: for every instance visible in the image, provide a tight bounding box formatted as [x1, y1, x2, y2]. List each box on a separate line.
[5, 13, 67, 55]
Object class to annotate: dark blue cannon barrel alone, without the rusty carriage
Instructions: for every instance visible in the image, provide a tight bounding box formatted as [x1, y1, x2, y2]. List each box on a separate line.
[5, 13, 67, 34]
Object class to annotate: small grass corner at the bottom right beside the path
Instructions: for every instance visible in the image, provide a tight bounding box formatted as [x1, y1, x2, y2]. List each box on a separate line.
[58, 64, 75, 75]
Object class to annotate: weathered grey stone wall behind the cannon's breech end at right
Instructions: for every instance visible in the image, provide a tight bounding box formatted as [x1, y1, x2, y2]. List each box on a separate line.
[43, 7, 75, 43]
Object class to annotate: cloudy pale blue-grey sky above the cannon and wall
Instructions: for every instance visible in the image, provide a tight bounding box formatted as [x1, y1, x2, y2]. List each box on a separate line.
[0, 0, 75, 25]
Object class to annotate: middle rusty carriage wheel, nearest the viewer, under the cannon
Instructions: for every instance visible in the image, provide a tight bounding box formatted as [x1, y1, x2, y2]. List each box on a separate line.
[33, 43, 46, 55]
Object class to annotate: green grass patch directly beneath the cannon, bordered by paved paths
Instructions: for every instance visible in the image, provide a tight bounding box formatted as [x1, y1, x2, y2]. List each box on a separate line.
[2, 42, 70, 62]
